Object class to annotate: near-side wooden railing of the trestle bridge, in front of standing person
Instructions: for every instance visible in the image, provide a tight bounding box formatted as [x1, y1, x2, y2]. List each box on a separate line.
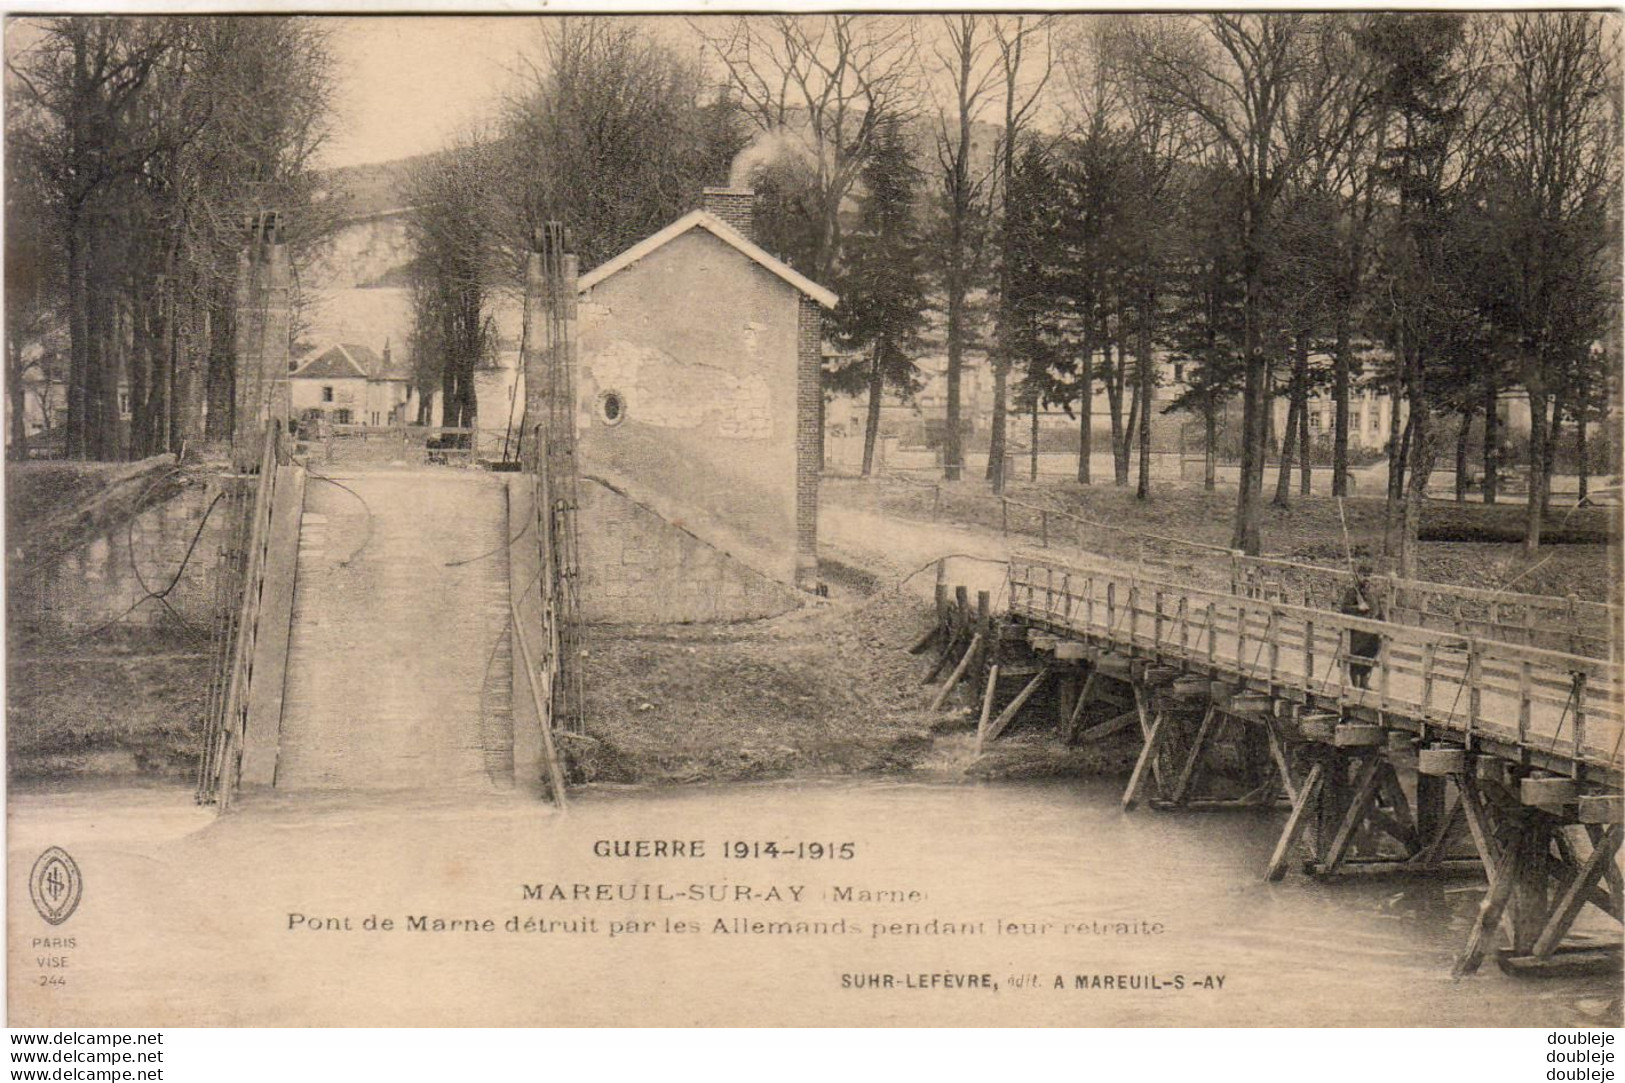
[1009, 556, 1625, 774]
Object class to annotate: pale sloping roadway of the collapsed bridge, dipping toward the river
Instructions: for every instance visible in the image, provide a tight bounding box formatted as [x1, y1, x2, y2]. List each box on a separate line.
[275, 467, 514, 792]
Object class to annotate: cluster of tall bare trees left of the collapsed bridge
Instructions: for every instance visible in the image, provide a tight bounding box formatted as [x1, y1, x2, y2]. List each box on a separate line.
[5, 16, 333, 459]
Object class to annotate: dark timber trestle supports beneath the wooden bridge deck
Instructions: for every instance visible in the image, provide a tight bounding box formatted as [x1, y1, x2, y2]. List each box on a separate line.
[913, 572, 1625, 976]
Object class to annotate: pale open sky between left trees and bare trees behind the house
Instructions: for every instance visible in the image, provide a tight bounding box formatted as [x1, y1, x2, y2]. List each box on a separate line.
[322, 16, 536, 167]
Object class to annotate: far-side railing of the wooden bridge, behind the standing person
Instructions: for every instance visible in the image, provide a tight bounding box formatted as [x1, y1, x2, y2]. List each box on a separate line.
[1230, 553, 1620, 660]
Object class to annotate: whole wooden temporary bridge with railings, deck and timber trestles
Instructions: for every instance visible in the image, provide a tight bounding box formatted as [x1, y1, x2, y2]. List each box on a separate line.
[915, 543, 1625, 974]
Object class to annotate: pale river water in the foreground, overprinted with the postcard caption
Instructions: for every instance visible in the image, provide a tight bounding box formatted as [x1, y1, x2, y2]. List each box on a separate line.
[8, 781, 1620, 1026]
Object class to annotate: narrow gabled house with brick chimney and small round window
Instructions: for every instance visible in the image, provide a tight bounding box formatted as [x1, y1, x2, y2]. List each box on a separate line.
[575, 189, 835, 621]
